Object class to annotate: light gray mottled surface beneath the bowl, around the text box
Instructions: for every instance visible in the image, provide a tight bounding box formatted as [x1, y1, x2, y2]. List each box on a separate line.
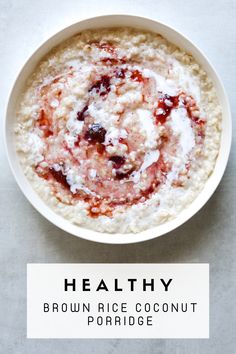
[0, 0, 236, 354]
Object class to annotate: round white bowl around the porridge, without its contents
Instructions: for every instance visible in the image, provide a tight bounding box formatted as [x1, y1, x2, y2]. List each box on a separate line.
[5, 15, 232, 243]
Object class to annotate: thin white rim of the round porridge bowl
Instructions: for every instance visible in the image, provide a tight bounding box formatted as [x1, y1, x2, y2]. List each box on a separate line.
[3, 14, 232, 244]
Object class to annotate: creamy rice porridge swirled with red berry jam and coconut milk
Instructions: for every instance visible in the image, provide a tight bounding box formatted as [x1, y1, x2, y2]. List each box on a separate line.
[16, 28, 221, 233]
